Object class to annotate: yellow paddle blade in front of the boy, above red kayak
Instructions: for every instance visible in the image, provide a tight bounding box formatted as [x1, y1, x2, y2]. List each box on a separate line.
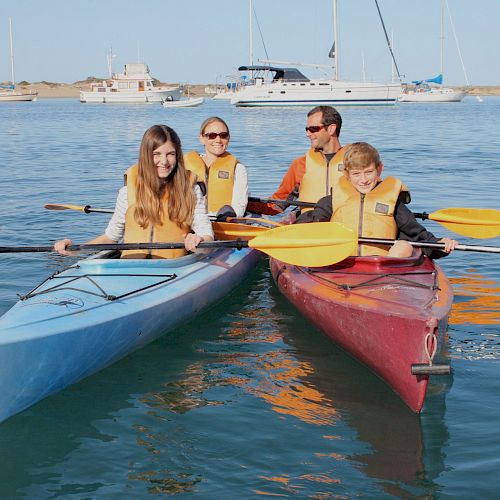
[248, 222, 357, 267]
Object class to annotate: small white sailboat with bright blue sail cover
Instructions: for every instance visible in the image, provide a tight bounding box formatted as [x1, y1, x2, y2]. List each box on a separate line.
[399, 0, 467, 103]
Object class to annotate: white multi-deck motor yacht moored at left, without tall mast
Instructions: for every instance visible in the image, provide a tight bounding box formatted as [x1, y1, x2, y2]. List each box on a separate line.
[80, 63, 181, 103]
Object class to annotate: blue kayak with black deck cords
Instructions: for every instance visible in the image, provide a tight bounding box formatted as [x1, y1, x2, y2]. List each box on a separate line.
[0, 249, 259, 422]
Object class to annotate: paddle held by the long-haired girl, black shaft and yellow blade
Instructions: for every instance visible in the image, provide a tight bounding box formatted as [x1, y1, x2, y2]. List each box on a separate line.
[0, 222, 356, 267]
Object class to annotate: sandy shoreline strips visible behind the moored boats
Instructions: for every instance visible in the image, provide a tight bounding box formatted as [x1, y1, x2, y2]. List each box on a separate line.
[10, 83, 500, 99]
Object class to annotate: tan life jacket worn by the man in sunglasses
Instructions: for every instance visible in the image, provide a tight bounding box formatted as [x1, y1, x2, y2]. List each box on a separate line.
[299, 147, 345, 212]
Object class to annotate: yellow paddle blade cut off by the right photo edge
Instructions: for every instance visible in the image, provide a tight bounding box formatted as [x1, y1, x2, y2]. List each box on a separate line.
[429, 208, 500, 238]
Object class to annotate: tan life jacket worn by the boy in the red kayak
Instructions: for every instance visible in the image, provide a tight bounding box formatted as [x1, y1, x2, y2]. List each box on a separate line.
[331, 177, 407, 255]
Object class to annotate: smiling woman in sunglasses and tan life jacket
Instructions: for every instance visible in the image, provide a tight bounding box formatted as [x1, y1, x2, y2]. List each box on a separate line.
[184, 116, 248, 217]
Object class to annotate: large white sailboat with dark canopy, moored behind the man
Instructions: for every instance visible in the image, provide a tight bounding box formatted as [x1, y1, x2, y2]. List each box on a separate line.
[231, 0, 401, 107]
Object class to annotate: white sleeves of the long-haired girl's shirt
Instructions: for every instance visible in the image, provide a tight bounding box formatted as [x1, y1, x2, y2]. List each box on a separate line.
[105, 185, 214, 242]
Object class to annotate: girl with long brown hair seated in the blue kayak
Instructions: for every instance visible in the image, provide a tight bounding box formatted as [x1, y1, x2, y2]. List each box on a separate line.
[54, 125, 213, 259]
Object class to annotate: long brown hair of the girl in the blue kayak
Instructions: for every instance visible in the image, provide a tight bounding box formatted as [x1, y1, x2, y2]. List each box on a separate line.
[134, 125, 196, 228]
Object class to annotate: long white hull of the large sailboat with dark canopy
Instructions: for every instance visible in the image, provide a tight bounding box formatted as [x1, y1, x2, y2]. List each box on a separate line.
[231, 80, 401, 107]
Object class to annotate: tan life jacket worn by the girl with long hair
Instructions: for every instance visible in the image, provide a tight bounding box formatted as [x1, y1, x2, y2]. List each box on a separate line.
[121, 165, 197, 259]
